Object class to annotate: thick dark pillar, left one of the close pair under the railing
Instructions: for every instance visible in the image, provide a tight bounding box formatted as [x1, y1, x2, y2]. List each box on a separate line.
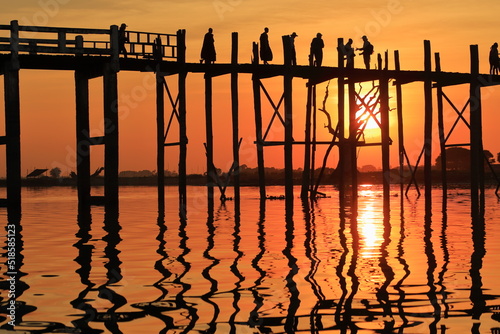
[75, 70, 91, 207]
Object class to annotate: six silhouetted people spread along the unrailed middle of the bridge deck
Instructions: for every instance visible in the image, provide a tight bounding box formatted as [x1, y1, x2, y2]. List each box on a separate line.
[200, 27, 373, 70]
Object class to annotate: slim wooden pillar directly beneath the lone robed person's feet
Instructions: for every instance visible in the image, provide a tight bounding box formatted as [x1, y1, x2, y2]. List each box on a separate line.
[205, 71, 216, 203]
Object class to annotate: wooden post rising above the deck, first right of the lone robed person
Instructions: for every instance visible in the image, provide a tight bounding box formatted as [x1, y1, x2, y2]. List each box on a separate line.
[231, 32, 240, 202]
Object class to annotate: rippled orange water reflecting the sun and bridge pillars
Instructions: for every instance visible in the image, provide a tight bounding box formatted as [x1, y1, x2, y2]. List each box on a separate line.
[0, 186, 500, 334]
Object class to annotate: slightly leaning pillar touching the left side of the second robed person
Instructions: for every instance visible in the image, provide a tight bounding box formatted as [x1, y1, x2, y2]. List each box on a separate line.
[252, 43, 266, 200]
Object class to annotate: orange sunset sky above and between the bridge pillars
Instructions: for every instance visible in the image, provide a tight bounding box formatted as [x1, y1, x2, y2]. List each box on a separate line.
[0, 0, 500, 177]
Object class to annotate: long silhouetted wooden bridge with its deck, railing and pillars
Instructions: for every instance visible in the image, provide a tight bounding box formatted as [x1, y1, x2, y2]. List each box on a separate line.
[0, 21, 500, 217]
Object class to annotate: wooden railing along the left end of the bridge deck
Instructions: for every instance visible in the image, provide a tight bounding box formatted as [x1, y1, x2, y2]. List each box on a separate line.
[0, 21, 177, 59]
